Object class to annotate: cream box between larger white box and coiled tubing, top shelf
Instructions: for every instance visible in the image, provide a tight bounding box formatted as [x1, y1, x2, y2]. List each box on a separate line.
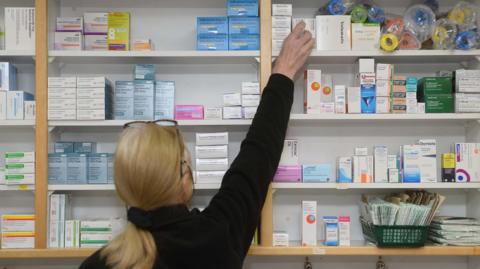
[352, 23, 380, 50]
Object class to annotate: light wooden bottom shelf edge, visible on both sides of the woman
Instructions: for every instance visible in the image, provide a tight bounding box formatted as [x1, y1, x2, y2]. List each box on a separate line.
[0, 246, 480, 259]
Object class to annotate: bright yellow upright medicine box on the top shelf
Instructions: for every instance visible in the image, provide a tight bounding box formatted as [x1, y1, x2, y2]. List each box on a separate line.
[107, 12, 130, 51]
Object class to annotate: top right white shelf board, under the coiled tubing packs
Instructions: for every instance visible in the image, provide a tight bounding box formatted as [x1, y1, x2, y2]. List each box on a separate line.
[273, 50, 480, 64]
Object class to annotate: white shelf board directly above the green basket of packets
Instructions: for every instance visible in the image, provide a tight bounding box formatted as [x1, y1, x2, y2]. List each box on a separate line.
[273, 182, 480, 190]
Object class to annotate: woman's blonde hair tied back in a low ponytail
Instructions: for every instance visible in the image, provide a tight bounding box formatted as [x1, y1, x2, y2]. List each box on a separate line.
[101, 124, 186, 269]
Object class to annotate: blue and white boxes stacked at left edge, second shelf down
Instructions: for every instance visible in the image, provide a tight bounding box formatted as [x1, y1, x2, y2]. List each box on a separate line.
[0, 62, 35, 120]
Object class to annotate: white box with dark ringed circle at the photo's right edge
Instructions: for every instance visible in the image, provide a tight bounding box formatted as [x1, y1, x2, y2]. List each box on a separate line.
[455, 143, 480, 182]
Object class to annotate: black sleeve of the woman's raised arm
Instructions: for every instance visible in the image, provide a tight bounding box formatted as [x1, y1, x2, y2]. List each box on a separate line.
[202, 74, 294, 257]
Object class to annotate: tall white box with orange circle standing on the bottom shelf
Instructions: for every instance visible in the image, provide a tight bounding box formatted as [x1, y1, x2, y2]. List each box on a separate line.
[302, 201, 317, 246]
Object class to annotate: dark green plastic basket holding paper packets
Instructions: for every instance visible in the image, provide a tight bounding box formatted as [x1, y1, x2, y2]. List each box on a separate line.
[361, 218, 429, 248]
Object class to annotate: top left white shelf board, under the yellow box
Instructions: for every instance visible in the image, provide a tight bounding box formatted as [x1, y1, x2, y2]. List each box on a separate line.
[49, 50, 260, 64]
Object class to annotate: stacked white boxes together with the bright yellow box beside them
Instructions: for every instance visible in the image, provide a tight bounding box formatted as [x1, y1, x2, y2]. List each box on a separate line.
[54, 12, 130, 51]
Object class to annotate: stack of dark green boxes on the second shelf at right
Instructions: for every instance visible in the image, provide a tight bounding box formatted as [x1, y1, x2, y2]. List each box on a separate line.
[417, 77, 455, 113]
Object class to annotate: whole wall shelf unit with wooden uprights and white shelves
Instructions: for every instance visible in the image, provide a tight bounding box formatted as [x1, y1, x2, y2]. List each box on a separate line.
[0, 0, 480, 267]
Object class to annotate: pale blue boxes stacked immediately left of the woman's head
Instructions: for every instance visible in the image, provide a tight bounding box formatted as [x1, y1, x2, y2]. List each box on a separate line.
[48, 142, 113, 184]
